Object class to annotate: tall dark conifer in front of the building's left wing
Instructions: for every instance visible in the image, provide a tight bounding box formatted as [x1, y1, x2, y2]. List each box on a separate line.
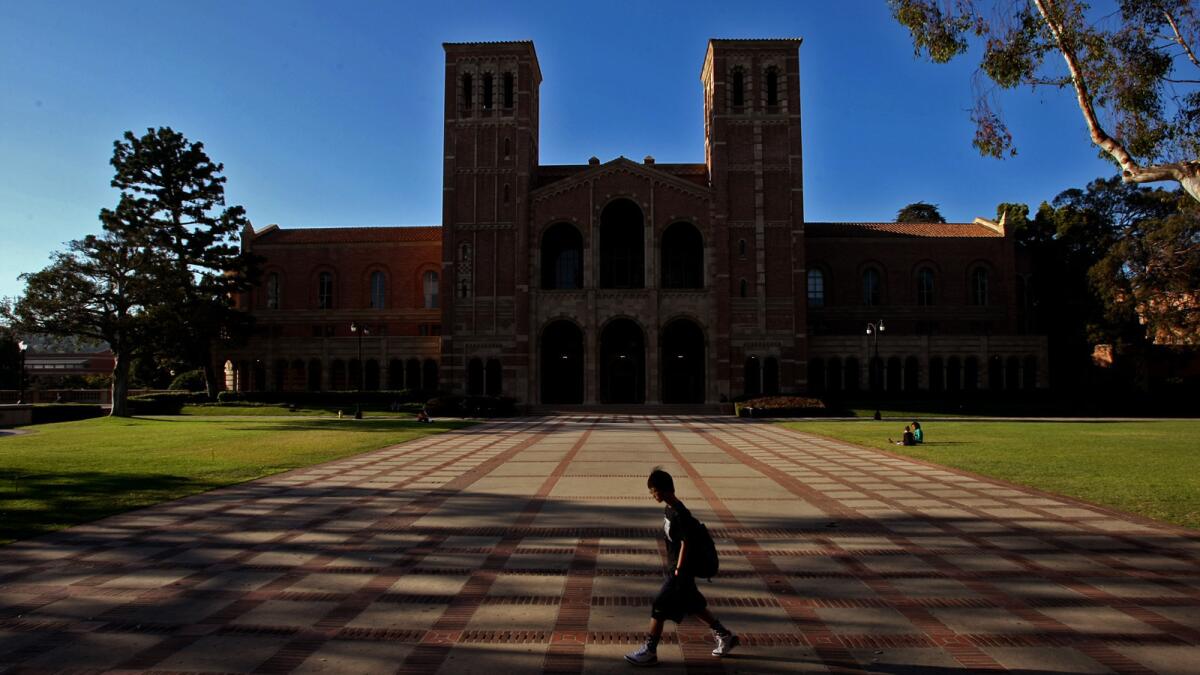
[104, 127, 257, 398]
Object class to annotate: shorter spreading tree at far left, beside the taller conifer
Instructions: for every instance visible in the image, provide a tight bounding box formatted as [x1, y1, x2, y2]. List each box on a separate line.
[2, 227, 162, 417]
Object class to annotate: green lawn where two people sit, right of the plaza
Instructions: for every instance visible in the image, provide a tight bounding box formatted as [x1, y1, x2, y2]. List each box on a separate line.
[781, 420, 1200, 528]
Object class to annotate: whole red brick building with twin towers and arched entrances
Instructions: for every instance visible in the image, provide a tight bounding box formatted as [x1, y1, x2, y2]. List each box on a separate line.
[226, 40, 1046, 404]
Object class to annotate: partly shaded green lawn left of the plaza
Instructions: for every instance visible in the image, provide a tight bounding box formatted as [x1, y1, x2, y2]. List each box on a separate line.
[0, 417, 470, 543]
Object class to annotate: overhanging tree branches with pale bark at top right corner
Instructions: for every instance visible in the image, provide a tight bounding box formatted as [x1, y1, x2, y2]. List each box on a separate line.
[888, 0, 1200, 201]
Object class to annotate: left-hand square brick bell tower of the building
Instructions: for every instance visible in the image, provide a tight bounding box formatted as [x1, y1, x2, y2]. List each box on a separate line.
[440, 42, 541, 399]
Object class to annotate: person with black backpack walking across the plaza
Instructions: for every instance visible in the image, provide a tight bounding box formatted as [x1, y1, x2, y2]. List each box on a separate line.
[625, 467, 739, 665]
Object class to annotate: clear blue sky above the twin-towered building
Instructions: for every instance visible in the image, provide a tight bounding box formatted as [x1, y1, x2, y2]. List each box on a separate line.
[0, 0, 1112, 297]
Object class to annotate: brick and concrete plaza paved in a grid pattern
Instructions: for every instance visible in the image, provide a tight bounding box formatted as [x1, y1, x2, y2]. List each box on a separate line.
[0, 416, 1200, 674]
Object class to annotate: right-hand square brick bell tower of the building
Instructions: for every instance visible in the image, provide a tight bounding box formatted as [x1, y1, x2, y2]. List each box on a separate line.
[701, 38, 808, 392]
